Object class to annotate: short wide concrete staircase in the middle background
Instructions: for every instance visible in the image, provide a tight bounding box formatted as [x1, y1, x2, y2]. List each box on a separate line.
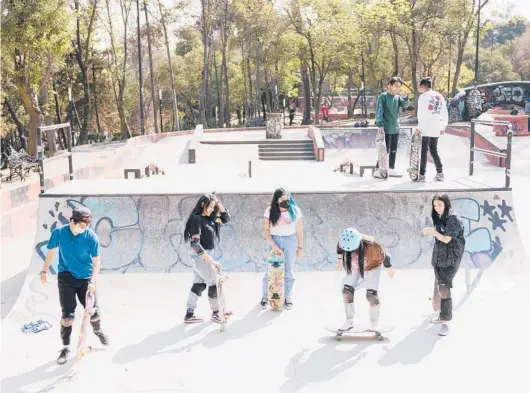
[258, 139, 316, 161]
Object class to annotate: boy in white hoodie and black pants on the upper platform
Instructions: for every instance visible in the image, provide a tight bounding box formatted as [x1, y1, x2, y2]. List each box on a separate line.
[418, 78, 449, 181]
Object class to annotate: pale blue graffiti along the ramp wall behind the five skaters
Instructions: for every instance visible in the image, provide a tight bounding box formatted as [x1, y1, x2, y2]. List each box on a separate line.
[36, 193, 517, 273]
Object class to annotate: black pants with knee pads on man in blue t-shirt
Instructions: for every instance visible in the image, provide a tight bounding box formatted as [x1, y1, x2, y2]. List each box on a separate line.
[57, 272, 100, 345]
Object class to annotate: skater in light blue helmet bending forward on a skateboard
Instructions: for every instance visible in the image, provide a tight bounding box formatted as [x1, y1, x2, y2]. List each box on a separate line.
[337, 228, 394, 331]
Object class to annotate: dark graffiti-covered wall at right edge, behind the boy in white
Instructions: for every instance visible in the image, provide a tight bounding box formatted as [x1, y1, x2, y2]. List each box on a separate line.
[449, 81, 530, 123]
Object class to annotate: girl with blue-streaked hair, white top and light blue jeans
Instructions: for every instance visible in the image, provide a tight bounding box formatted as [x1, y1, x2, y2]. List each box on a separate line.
[260, 188, 304, 310]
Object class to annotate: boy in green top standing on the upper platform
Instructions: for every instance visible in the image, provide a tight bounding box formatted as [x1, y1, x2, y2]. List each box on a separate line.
[374, 76, 410, 179]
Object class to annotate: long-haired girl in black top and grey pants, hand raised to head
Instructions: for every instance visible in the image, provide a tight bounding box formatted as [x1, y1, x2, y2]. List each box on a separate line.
[184, 194, 230, 323]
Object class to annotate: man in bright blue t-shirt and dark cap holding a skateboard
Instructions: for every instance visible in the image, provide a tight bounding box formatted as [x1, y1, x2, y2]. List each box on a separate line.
[40, 207, 109, 364]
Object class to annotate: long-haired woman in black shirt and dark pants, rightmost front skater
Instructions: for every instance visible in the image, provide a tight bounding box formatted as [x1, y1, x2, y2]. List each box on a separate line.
[423, 193, 466, 336]
